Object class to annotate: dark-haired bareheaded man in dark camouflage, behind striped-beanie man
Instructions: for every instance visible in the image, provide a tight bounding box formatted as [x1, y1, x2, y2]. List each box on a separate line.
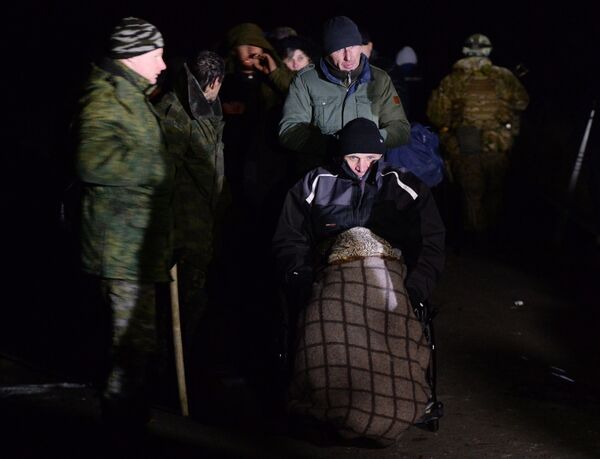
[156, 51, 228, 357]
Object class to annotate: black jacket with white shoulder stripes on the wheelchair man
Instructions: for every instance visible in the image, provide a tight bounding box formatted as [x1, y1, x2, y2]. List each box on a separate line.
[273, 161, 445, 301]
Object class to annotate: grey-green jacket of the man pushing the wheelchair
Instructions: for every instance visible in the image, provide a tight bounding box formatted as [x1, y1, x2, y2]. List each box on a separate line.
[279, 56, 410, 172]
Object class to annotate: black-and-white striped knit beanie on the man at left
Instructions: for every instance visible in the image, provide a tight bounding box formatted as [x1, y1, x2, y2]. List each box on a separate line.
[110, 16, 165, 59]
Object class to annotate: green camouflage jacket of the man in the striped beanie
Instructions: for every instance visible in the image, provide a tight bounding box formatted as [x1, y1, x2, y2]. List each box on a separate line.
[75, 59, 175, 282]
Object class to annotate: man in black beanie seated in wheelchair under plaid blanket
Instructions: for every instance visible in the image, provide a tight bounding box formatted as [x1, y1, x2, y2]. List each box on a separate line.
[273, 118, 445, 445]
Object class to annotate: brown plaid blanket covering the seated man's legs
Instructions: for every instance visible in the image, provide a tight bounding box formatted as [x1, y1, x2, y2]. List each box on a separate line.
[289, 241, 431, 445]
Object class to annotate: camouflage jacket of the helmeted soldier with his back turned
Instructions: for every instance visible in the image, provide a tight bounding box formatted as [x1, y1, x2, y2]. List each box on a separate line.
[427, 57, 529, 155]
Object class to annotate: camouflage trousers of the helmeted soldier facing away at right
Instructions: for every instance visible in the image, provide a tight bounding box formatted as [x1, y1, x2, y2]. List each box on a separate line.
[450, 152, 508, 231]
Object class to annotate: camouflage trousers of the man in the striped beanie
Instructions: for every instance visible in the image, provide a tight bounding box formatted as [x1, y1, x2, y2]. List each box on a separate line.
[100, 279, 156, 400]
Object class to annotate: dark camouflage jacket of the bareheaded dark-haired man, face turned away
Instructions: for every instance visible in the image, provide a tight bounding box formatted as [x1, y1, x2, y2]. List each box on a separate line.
[156, 65, 226, 263]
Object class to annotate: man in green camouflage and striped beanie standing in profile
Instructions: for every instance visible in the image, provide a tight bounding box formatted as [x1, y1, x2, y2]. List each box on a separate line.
[76, 17, 175, 425]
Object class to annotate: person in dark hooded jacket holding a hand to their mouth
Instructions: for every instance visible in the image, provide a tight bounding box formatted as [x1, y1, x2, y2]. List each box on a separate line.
[221, 23, 294, 212]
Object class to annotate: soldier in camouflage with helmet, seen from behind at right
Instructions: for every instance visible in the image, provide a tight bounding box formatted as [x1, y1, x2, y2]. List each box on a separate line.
[427, 34, 529, 237]
